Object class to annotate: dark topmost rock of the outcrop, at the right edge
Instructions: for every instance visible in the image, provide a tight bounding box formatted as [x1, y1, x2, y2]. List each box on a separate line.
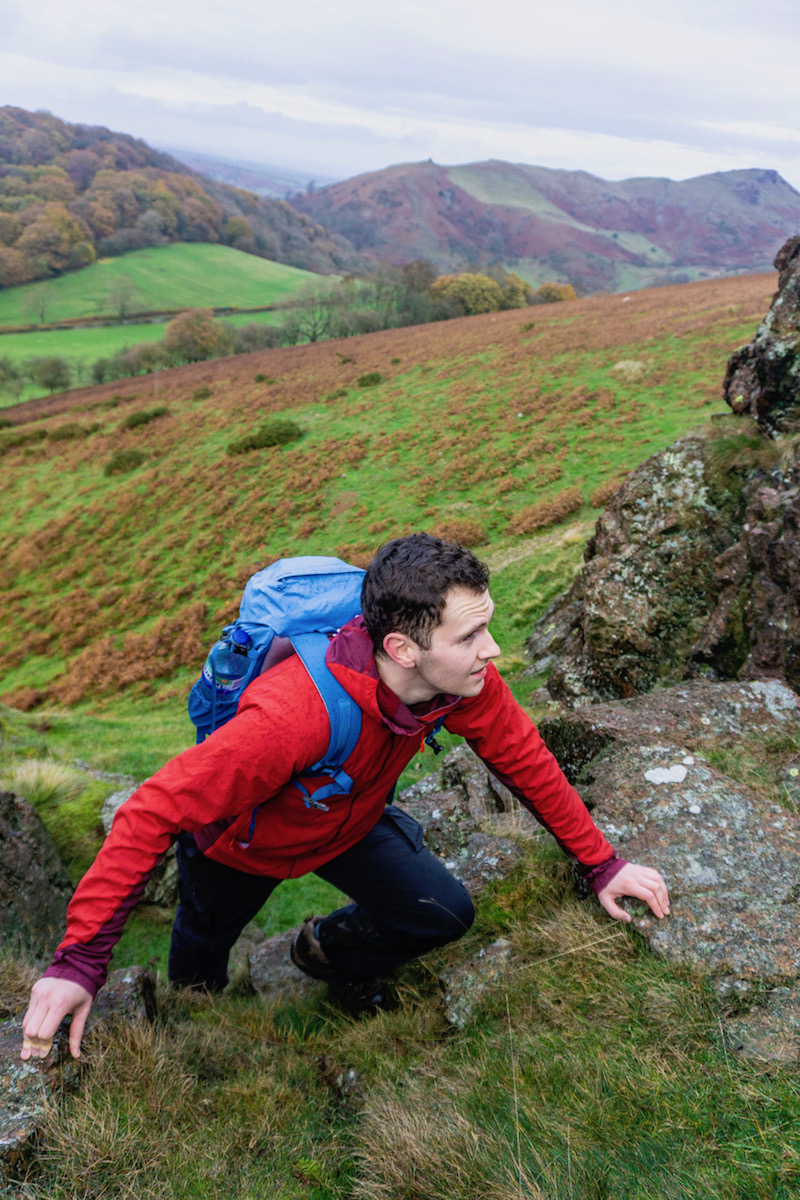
[724, 236, 800, 434]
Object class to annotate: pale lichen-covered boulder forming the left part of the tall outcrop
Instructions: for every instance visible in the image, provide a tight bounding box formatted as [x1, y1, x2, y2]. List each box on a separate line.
[527, 436, 734, 703]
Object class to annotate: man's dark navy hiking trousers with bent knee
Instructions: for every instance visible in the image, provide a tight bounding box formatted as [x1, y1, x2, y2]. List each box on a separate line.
[169, 805, 475, 991]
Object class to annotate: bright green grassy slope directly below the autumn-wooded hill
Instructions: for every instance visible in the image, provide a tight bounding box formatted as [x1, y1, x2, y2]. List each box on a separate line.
[0, 242, 318, 326]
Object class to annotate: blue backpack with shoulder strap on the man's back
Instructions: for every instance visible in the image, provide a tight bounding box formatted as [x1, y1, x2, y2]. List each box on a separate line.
[188, 556, 365, 809]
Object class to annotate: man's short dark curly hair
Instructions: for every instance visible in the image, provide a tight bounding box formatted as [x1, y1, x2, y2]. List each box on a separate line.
[361, 533, 489, 654]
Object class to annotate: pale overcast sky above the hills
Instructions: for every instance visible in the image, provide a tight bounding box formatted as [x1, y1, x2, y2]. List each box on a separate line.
[0, 0, 800, 191]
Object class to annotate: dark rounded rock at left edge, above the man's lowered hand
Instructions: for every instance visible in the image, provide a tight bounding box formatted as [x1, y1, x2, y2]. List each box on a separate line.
[0, 792, 72, 956]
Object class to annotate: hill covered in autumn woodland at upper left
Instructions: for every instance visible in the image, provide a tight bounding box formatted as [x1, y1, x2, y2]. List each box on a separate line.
[0, 107, 359, 287]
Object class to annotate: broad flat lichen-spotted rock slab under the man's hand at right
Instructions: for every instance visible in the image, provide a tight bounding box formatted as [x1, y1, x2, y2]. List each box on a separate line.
[541, 680, 800, 983]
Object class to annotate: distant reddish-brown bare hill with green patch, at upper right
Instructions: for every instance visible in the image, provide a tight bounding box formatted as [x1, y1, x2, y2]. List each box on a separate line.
[291, 161, 800, 292]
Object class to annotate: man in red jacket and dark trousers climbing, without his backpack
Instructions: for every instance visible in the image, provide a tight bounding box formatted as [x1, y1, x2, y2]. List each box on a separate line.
[22, 534, 669, 1058]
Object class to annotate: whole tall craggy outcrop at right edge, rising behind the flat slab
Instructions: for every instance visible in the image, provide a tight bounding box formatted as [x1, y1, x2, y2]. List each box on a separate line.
[528, 238, 800, 704]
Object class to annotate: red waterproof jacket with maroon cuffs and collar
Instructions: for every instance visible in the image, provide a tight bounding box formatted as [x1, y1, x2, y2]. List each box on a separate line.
[46, 618, 624, 995]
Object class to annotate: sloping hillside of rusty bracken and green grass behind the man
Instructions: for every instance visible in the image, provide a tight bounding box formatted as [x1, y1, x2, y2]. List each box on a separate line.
[0, 276, 774, 736]
